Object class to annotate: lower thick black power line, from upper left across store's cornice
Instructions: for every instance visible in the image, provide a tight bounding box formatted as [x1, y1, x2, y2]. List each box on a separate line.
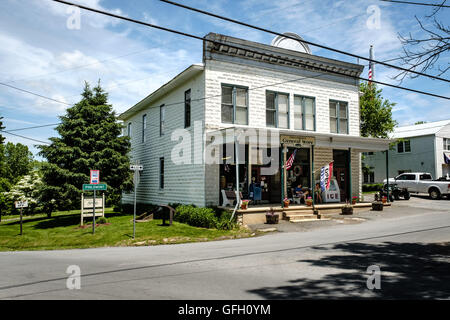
[52, 0, 450, 100]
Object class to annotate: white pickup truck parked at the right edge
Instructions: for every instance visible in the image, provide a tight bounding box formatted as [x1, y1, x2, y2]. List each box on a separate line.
[383, 172, 450, 199]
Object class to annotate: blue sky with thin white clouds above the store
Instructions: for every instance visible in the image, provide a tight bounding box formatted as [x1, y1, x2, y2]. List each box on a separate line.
[0, 0, 450, 158]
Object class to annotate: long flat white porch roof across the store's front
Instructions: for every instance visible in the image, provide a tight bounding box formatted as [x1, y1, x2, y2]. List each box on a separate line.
[206, 125, 395, 152]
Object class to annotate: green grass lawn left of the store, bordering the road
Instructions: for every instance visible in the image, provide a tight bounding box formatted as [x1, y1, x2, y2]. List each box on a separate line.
[0, 209, 254, 251]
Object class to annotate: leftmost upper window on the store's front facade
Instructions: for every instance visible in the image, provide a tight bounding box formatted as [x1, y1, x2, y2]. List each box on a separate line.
[222, 85, 248, 125]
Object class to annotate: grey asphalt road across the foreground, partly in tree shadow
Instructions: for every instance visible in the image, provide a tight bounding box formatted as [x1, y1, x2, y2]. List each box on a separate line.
[0, 197, 450, 300]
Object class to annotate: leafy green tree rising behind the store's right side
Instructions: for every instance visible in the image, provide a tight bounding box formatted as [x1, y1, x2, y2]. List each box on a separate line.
[359, 82, 397, 138]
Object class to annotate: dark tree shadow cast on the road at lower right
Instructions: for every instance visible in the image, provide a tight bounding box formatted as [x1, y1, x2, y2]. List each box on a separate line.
[249, 242, 450, 299]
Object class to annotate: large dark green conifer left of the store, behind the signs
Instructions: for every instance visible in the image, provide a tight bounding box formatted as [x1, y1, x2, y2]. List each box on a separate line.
[40, 82, 132, 215]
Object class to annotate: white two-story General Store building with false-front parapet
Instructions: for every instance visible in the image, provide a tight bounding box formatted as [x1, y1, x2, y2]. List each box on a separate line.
[120, 33, 390, 206]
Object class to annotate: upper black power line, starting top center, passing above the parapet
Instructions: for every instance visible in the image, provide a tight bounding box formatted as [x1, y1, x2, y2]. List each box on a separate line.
[160, 0, 450, 82]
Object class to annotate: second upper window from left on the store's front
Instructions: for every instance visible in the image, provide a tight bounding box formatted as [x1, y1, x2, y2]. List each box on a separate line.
[266, 91, 289, 129]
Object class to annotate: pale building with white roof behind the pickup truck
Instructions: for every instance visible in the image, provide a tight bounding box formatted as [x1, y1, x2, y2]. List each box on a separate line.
[363, 120, 450, 183]
